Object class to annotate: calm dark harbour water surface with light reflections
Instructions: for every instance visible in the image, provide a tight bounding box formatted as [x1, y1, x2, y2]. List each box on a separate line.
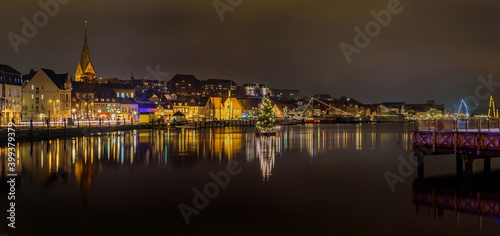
[0, 124, 500, 236]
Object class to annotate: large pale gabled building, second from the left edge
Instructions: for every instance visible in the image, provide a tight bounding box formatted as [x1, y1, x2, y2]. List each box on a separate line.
[22, 69, 72, 121]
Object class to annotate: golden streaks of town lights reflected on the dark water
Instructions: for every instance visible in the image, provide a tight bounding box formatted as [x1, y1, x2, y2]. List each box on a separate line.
[0, 124, 410, 187]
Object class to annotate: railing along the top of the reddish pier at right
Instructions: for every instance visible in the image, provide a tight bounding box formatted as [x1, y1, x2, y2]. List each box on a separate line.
[415, 118, 500, 132]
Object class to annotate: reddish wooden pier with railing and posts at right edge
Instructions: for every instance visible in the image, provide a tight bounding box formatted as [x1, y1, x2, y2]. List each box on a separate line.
[412, 119, 500, 178]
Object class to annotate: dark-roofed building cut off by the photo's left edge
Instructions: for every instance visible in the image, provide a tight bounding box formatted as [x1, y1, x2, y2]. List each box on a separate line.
[0, 64, 22, 124]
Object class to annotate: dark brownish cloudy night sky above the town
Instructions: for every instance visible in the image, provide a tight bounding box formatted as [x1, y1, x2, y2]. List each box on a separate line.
[0, 0, 500, 111]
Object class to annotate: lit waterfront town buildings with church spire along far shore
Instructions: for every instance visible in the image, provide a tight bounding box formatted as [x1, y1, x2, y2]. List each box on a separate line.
[0, 22, 448, 124]
